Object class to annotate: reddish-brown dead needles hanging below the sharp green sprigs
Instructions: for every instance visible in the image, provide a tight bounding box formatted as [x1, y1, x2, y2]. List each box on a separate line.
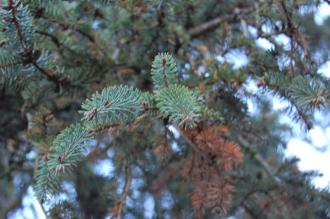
[181, 126, 243, 218]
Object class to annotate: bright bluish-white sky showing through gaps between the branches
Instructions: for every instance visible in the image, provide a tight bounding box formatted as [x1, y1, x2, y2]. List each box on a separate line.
[0, 2, 330, 219]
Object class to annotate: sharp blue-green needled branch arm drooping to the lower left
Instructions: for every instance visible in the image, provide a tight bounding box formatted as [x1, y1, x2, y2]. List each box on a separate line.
[35, 86, 142, 198]
